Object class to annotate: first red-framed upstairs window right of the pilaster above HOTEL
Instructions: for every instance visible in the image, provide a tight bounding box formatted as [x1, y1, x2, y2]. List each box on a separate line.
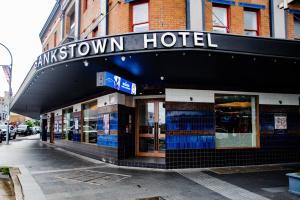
[212, 5, 229, 33]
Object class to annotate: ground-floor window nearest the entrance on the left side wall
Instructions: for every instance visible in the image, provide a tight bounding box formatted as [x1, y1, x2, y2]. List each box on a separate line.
[82, 101, 98, 143]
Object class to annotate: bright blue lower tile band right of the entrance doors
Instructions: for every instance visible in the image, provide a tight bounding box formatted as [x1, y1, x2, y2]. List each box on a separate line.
[166, 135, 215, 150]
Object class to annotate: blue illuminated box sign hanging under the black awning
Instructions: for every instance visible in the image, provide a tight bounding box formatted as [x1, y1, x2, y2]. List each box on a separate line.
[97, 72, 136, 95]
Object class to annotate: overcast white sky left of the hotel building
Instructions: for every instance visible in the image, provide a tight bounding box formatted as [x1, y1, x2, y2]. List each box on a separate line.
[0, 0, 56, 96]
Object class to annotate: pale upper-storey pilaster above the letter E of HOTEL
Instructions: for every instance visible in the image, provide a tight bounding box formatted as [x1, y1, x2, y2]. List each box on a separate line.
[190, 0, 203, 31]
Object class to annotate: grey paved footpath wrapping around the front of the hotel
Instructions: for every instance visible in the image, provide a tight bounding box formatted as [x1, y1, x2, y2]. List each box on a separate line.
[0, 135, 300, 200]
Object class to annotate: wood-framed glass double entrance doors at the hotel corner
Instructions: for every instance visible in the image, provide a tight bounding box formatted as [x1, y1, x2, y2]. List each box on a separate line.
[136, 99, 166, 157]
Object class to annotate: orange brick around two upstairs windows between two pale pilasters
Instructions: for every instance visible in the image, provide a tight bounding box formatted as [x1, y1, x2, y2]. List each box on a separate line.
[205, 0, 270, 37]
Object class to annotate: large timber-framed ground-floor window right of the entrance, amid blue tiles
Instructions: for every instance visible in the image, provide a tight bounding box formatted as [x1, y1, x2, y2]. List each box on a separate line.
[215, 94, 258, 148]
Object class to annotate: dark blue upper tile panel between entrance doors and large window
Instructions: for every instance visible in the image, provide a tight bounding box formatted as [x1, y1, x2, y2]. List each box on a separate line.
[166, 111, 215, 131]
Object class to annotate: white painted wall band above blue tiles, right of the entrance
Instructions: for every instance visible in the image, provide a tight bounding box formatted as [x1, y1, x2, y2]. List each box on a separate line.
[166, 88, 300, 105]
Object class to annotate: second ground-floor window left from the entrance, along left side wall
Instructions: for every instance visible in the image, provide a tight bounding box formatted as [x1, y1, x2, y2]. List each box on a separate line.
[63, 108, 74, 140]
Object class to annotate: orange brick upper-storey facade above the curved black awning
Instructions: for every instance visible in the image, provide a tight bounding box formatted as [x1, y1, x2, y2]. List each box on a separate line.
[41, 0, 300, 51]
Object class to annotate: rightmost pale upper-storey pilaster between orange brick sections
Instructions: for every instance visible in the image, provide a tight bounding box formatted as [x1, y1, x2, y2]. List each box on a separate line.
[273, 0, 286, 38]
